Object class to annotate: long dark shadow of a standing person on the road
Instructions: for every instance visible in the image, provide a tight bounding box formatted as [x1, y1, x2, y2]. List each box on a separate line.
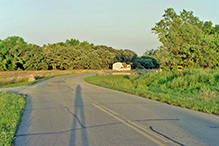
[69, 85, 89, 146]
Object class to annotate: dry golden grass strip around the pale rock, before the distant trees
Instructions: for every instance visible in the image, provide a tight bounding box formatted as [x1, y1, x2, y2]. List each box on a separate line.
[0, 70, 98, 88]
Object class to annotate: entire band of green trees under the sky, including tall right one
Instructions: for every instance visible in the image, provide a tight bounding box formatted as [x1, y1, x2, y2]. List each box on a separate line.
[3, 8, 214, 71]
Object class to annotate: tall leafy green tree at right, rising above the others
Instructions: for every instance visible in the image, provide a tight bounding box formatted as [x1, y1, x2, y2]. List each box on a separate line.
[144, 8, 219, 69]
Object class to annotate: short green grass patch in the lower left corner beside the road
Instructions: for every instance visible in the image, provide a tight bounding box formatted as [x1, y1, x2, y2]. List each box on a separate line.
[0, 92, 26, 146]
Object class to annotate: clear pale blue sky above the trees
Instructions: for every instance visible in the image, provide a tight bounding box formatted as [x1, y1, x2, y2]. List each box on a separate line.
[0, 0, 219, 56]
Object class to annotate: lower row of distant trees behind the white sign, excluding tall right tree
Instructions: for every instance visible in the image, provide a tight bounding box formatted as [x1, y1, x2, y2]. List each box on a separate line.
[0, 36, 159, 71]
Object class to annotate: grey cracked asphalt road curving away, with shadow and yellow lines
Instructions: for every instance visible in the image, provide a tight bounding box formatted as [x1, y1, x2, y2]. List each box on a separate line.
[0, 74, 219, 146]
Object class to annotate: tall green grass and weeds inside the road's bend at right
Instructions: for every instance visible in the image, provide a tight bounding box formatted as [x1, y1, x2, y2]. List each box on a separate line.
[85, 69, 219, 115]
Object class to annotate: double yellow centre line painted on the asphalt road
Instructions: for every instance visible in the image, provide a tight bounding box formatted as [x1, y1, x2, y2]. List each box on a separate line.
[93, 104, 165, 146]
